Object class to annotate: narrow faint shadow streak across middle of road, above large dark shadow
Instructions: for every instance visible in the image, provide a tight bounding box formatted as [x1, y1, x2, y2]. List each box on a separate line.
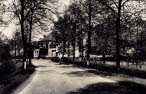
[64, 71, 96, 77]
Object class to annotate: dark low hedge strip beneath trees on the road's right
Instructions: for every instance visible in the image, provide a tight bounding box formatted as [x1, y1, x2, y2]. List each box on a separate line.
[64, 59, 146, 79]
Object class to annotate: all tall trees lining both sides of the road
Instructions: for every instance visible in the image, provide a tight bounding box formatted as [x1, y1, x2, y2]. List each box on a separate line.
[1, 0, 145, 69]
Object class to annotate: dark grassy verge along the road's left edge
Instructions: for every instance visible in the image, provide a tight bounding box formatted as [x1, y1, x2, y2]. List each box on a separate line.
[0, 62, 35, 94]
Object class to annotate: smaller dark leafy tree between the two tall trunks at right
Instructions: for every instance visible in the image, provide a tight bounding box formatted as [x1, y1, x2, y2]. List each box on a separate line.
[92, 15, 115, 63]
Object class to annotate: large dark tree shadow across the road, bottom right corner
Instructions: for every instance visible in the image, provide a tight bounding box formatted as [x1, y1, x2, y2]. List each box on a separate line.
[68, 81, 146, 94]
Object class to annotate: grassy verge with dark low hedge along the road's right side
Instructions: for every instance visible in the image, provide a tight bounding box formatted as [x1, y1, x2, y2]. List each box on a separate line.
[50, 57, 146, 85]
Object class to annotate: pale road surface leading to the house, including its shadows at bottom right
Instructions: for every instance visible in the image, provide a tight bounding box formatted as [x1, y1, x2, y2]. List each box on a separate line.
[12, 60, 145, 94]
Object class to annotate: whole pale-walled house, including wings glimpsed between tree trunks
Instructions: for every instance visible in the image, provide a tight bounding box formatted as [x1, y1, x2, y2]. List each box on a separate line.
[33, 33, 85, 59]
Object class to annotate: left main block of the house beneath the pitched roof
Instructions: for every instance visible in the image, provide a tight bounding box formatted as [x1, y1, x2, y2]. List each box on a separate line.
[33, 33, 59, 58]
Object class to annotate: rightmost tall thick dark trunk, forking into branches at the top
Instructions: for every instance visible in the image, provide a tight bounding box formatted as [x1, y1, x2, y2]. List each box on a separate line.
[97, 0, 129, 69]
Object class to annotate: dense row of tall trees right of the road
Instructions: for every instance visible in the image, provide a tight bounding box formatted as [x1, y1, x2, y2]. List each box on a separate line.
[54, 0, 145, 69]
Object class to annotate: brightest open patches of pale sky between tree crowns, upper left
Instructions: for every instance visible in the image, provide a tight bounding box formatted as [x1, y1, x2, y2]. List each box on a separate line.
[0, 0, 70, 38]
